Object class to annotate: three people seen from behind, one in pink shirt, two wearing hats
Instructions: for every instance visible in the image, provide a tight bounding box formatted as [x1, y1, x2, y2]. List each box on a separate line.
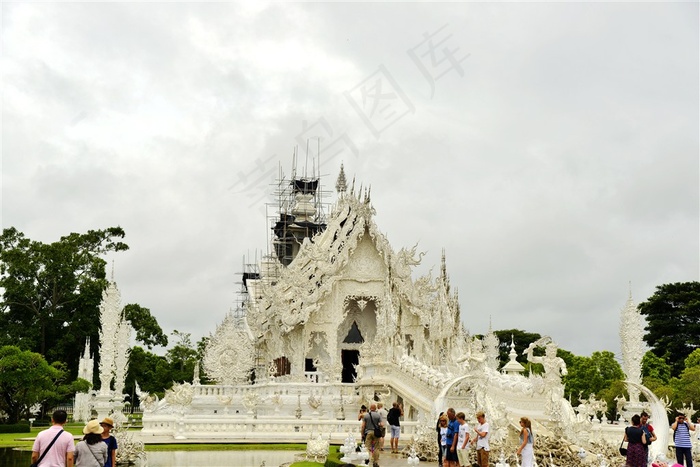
[32, 410, 118, 467]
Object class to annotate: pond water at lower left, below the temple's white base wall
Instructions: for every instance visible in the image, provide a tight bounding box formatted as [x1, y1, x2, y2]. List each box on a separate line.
[0, 448, 300, 467]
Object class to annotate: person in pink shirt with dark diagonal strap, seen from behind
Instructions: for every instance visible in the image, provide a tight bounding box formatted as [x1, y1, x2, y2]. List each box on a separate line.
[32, 410, 75, 467]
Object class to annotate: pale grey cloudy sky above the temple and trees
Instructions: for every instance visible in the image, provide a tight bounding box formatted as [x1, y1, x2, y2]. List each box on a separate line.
[2, 2, 700, 355]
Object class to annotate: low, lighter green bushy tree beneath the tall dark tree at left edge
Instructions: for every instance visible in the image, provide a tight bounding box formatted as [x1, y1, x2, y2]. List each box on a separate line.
[0, 345, 89, 423]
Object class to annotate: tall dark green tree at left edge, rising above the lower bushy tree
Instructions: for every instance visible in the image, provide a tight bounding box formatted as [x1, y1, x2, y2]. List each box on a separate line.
[0, 227, 128, 374]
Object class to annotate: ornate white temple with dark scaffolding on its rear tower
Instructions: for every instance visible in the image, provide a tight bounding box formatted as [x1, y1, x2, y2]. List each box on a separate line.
[134, 166, 676, 462]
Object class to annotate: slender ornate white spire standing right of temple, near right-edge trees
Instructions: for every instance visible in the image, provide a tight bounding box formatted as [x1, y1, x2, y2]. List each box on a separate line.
[620, 285, 644, 402]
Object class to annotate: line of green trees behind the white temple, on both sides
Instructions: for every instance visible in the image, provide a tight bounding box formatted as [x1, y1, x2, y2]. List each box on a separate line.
[0, 227, 700, 422]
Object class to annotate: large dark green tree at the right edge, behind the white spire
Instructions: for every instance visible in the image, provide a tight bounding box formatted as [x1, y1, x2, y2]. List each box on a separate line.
[639, 282, 700, 376]
